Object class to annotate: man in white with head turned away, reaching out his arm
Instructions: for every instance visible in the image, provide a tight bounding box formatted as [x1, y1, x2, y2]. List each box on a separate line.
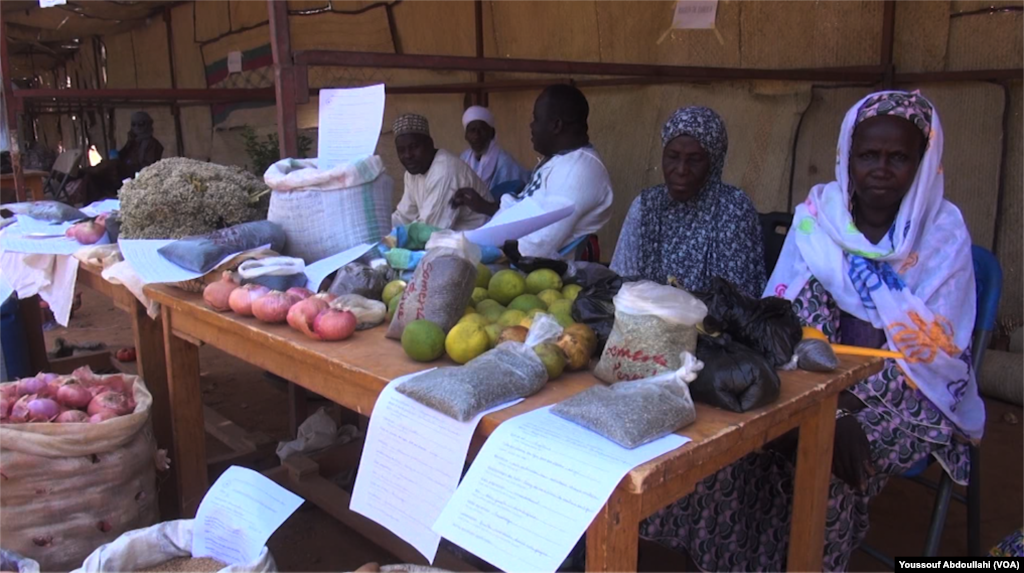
[452, 84, 612, 259]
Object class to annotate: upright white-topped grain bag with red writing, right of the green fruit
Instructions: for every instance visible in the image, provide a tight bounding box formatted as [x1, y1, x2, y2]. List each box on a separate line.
[594, 280, 708, 384]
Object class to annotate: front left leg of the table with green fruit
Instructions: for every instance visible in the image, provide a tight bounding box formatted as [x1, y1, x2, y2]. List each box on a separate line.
[161, 306, 209, 518]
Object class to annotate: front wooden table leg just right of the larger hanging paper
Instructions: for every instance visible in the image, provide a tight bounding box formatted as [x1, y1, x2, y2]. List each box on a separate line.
[587, 487, 641, 571]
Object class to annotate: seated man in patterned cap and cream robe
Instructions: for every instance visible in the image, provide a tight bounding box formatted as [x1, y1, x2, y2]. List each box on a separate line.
[391, 114, 490, 231]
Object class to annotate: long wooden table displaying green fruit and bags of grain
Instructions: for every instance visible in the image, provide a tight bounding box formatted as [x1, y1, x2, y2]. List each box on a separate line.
[146, 285, 882, 571]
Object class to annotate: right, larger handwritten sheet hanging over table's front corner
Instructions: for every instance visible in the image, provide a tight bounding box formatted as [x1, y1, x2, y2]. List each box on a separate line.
[434, 407, 690, 573]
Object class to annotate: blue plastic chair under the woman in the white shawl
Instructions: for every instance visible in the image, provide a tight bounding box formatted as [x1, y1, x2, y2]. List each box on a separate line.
[860, 245, 1002, 569]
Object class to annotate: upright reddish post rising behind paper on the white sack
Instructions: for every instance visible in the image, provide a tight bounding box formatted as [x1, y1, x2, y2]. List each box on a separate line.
[266, 0, 299, 159]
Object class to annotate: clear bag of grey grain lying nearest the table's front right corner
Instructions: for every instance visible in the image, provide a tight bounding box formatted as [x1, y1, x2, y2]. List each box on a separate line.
[551, 352, 703, 449]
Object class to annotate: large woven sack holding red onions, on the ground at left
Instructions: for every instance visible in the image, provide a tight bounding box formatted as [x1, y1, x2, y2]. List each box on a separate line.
[0, 374, 160, 571]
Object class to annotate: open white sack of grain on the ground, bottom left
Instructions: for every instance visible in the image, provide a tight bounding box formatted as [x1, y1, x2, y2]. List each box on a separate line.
[72, 520, 278, 573]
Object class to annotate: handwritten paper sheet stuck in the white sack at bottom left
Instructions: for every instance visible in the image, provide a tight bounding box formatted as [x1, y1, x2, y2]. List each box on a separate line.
[193, 466, 303, 565]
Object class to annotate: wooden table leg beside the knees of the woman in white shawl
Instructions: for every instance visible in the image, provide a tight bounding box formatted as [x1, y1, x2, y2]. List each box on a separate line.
[786, 395, 839, 571]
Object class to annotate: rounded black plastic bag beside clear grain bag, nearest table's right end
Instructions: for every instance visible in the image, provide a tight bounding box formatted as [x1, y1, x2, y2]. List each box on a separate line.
[690, 335, 781, 412]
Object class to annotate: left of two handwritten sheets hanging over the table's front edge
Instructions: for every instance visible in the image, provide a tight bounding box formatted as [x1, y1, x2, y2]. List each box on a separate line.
[349, 370, 521, 563]
